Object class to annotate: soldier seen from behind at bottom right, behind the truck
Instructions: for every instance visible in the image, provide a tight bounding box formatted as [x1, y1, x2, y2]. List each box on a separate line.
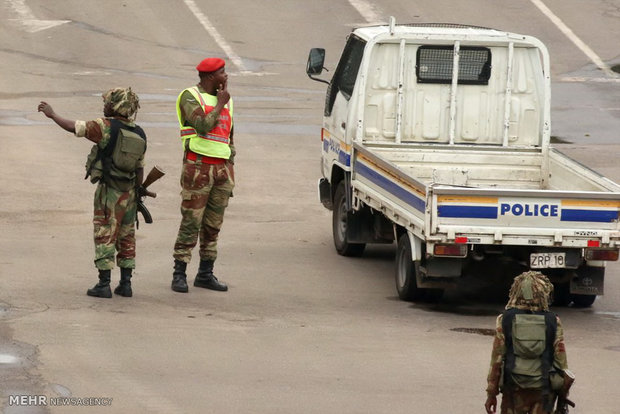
[485, 271, 568, 414]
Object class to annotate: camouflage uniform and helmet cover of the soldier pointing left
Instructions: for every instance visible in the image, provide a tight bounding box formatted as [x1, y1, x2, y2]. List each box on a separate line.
[75, 88, 144, 270]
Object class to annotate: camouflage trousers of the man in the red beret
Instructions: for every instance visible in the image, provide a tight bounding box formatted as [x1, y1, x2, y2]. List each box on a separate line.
[173, 160, 235, 263]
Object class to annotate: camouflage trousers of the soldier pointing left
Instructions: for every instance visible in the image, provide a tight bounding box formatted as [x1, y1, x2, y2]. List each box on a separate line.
[93, 184, 136, 270]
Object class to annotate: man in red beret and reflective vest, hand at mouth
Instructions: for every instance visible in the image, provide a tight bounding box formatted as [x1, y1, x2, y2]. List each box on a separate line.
[171, 58, 235, 292]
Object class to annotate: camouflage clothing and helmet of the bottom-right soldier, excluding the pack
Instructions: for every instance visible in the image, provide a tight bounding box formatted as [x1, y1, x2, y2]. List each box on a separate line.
[486, 271, 568, 414]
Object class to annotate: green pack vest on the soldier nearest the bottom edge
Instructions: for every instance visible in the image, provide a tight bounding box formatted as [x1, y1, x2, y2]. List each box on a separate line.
[502, 309, 557, 393]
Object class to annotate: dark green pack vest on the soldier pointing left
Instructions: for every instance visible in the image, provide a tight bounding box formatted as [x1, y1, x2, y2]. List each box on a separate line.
[84, 118, 146, 191]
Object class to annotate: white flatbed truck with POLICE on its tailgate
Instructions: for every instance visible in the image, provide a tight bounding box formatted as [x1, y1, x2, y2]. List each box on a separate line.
[306, 18, 620, 307]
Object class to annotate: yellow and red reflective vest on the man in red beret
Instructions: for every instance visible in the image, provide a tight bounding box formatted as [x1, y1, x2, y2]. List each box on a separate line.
[177, 86, 233, 159]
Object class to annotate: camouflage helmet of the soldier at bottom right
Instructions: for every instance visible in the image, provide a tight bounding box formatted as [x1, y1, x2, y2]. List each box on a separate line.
[506, 271, 553, 312]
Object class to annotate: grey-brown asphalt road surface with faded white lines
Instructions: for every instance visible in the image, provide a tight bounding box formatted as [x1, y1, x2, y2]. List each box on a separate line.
[0, 0, 620, 414]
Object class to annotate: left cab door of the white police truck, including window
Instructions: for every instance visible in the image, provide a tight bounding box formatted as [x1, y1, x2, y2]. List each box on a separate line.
[323, 35, 366, 161]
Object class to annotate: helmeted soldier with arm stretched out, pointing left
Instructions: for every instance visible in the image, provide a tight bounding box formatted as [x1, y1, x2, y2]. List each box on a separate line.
[38, 88, 146, 298]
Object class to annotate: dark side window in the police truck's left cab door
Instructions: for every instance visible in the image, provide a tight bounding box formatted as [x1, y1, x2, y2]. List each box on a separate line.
[325, 36, 366, 116]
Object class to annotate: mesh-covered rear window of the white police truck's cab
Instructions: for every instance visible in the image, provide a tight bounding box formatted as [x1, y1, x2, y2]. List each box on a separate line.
[416, 46, 491, 85]
